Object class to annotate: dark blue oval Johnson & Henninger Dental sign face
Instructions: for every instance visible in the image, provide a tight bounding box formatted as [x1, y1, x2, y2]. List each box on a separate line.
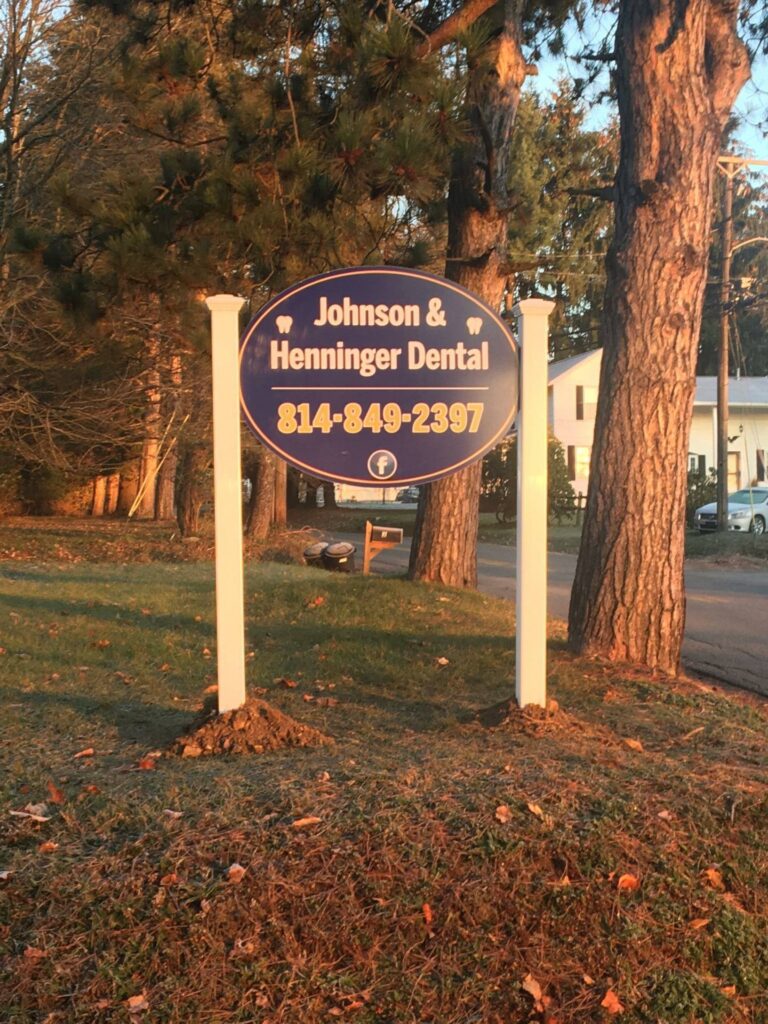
[240, 267, 517, 486]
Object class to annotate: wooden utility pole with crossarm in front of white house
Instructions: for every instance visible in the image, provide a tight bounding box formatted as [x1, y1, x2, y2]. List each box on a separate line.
[717, 155, 768, 530]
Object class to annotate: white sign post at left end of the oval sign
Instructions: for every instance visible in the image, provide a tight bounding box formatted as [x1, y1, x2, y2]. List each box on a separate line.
[206, 295, 246, 714]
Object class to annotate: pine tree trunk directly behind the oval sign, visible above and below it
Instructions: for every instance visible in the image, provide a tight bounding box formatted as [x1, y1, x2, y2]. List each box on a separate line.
[409, 0, 526, 587]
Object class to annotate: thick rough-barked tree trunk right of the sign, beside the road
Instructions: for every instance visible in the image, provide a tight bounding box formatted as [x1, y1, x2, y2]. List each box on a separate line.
[569, 0, 749, 675]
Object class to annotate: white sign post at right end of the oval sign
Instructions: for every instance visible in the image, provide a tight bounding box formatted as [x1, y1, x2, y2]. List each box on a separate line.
[512, 299, 555, 708]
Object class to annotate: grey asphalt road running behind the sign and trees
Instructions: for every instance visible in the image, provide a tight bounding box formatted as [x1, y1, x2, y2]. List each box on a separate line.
[344, 536, 768, 695]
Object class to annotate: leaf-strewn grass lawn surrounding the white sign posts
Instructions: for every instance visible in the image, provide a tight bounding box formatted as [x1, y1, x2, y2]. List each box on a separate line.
[0, 542, 768, 1024]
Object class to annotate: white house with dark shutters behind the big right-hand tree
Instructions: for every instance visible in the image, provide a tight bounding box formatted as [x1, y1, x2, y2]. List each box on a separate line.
[549, 349, 768, 494]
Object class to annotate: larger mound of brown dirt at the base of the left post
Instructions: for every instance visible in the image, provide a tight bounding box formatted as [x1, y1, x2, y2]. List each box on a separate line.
[171, 697, 333, 758]
